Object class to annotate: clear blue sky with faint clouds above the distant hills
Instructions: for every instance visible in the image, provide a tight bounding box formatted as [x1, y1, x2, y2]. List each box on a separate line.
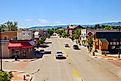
[0, 0, 121, 27]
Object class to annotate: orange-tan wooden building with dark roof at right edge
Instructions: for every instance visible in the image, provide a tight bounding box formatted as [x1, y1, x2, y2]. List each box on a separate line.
[93, 32, 121, 54]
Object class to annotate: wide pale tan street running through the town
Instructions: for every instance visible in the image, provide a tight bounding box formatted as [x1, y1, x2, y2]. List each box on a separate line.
[3, 37, 121, 81]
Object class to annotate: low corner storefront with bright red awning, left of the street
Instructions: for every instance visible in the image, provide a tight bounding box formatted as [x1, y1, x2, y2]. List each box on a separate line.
[8, 41, 33, 58]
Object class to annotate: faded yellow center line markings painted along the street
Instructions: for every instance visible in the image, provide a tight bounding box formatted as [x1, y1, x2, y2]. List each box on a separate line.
[58, 40, 83, 81]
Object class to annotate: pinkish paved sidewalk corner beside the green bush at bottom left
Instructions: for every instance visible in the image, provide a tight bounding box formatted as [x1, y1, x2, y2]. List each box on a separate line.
[11, 71, 33, 81]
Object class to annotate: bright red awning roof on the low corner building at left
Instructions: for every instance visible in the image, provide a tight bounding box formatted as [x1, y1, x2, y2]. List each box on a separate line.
[8, 42, 33, 48]
